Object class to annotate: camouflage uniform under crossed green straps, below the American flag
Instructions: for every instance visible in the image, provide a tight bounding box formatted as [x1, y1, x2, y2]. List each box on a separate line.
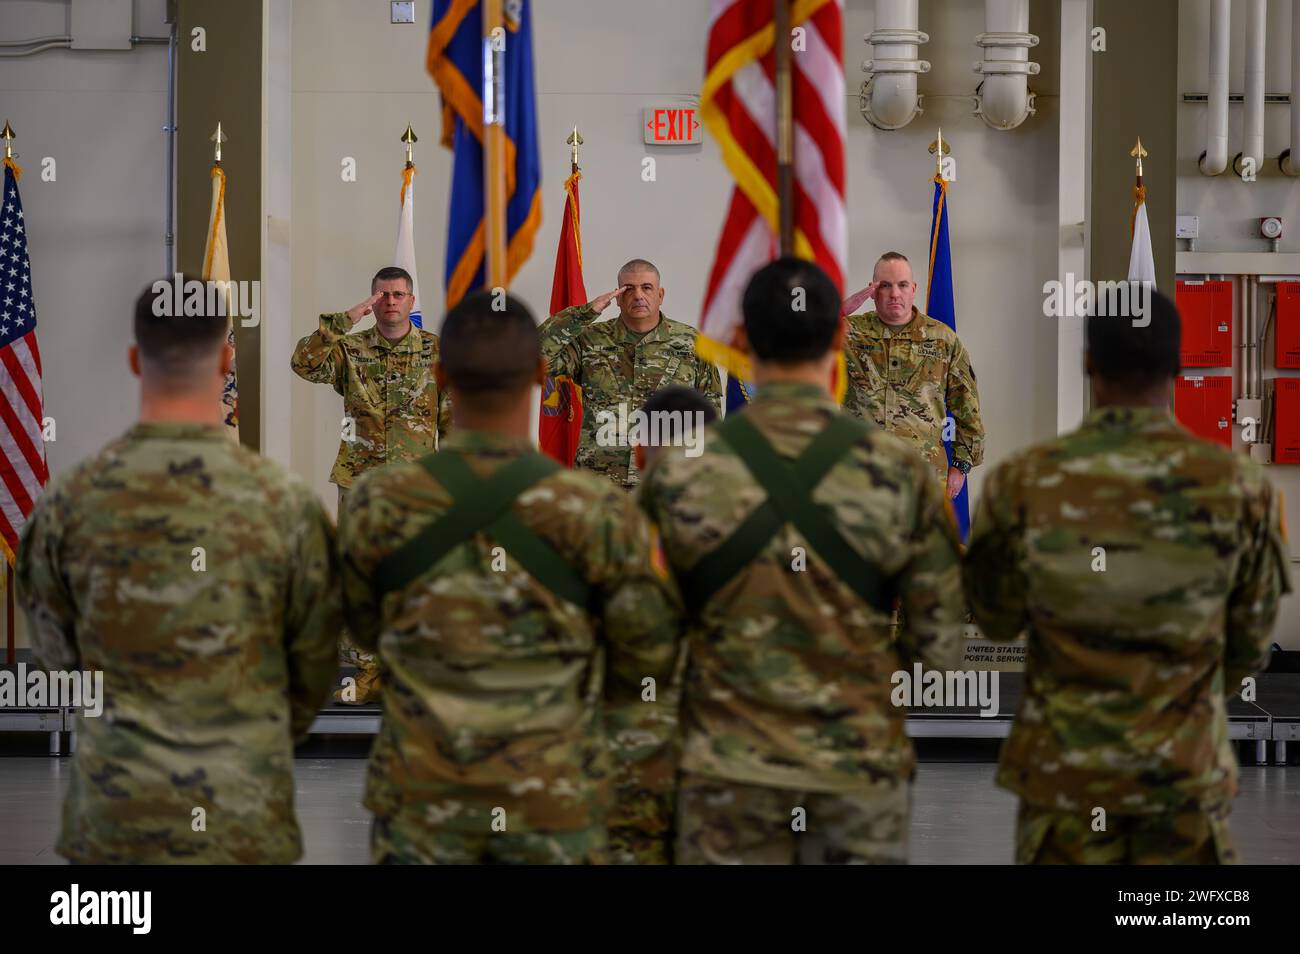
[641, 383, 962, 863]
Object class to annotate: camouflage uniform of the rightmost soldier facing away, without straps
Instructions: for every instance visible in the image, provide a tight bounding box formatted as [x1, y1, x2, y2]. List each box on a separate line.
[965, 407, 1290, 863]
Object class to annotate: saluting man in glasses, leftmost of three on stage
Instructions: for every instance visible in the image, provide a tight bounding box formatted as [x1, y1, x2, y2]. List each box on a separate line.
[290, 265, 451, 704]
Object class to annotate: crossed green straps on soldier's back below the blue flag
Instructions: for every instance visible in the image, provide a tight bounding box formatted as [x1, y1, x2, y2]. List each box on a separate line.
[376, 451, 590, 610]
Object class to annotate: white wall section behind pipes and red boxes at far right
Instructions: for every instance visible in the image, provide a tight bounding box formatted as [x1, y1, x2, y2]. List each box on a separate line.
[1178, 0, 1300, 650]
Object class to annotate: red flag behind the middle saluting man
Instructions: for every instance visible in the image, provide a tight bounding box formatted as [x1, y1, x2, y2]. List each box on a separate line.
[537, 169, 586, 469]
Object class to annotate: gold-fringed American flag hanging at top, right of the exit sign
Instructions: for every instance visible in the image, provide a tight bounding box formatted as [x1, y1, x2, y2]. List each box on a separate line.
[697, 0, 849, 380]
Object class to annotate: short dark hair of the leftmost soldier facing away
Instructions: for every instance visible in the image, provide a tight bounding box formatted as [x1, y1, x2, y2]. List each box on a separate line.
[133, 274, 230, 382]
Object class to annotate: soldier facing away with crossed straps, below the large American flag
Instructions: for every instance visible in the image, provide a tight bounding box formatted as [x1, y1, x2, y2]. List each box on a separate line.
[641, 259, 963, 864]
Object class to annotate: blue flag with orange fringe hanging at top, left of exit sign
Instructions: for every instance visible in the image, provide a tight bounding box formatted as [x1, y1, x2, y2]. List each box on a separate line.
[428, 0, 542, 308]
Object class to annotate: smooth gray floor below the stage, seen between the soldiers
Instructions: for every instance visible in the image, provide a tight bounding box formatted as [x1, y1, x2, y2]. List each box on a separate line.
[0, 758, 1300, 864]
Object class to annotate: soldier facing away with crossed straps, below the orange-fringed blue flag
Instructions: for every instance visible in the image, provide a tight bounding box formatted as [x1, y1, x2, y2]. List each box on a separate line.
[339, 292, 680, 864]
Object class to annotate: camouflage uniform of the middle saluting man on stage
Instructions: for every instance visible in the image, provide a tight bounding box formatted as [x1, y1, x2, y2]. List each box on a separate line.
[538, 304, 723, 487]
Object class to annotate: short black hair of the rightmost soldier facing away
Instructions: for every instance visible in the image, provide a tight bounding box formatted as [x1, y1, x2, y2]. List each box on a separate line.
[1086, 289, 1183, 390]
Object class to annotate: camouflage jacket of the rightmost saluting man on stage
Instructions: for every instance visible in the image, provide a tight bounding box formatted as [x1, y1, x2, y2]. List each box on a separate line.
[844, 308, 984, 486]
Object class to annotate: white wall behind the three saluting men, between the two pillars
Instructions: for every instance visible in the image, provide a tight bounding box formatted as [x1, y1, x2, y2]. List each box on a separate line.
[289, 0, 1058, 514]
